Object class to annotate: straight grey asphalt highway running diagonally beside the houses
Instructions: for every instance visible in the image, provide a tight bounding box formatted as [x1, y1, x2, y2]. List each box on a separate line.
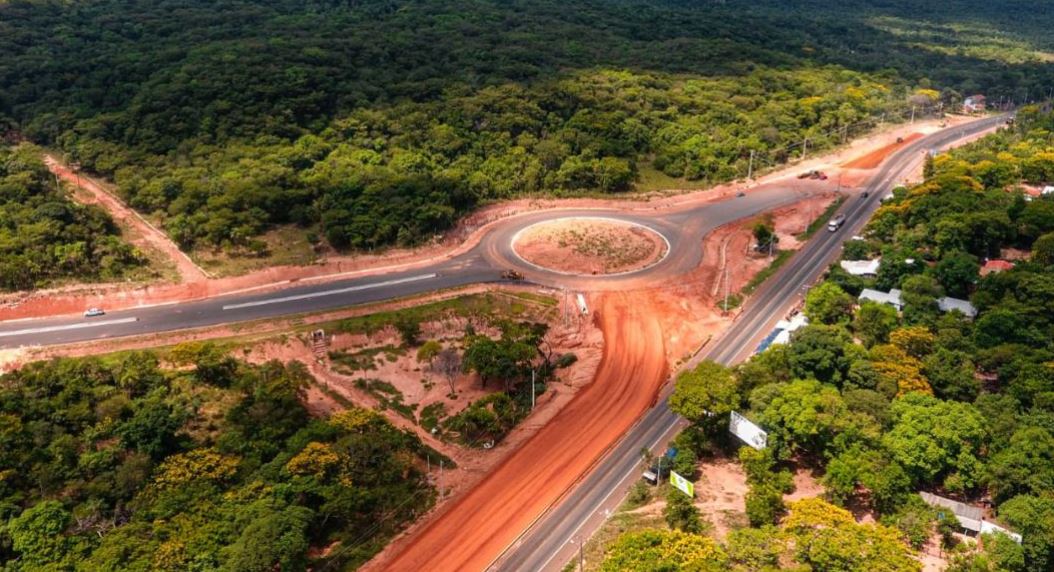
[490, 117, 1004, 572]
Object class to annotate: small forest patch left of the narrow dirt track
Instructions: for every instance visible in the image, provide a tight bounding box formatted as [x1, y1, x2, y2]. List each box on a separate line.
[0, 139, 143, 291]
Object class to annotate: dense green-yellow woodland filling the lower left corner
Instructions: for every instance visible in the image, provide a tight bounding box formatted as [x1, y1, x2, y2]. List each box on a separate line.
[0, 343, 440, 572]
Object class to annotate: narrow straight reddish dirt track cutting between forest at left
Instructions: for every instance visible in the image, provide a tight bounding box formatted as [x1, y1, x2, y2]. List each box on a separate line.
[44, 155, 207, 282]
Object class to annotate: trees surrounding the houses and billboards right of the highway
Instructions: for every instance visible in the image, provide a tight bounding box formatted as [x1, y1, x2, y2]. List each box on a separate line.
[605, 106, 1054, 572]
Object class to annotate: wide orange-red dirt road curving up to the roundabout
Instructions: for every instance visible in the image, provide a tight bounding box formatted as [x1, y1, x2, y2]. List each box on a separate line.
[375, 293, 667, 572]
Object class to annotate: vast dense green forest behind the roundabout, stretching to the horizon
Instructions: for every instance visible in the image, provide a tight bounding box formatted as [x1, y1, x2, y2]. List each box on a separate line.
[0, 0, 1054, 254]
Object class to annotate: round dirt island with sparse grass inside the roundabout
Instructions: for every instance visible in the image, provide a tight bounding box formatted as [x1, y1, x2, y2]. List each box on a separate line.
[512, 217, 669, 276]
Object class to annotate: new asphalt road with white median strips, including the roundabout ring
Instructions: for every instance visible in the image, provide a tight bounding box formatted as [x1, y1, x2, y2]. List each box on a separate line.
[0, 180, 801, 349]
